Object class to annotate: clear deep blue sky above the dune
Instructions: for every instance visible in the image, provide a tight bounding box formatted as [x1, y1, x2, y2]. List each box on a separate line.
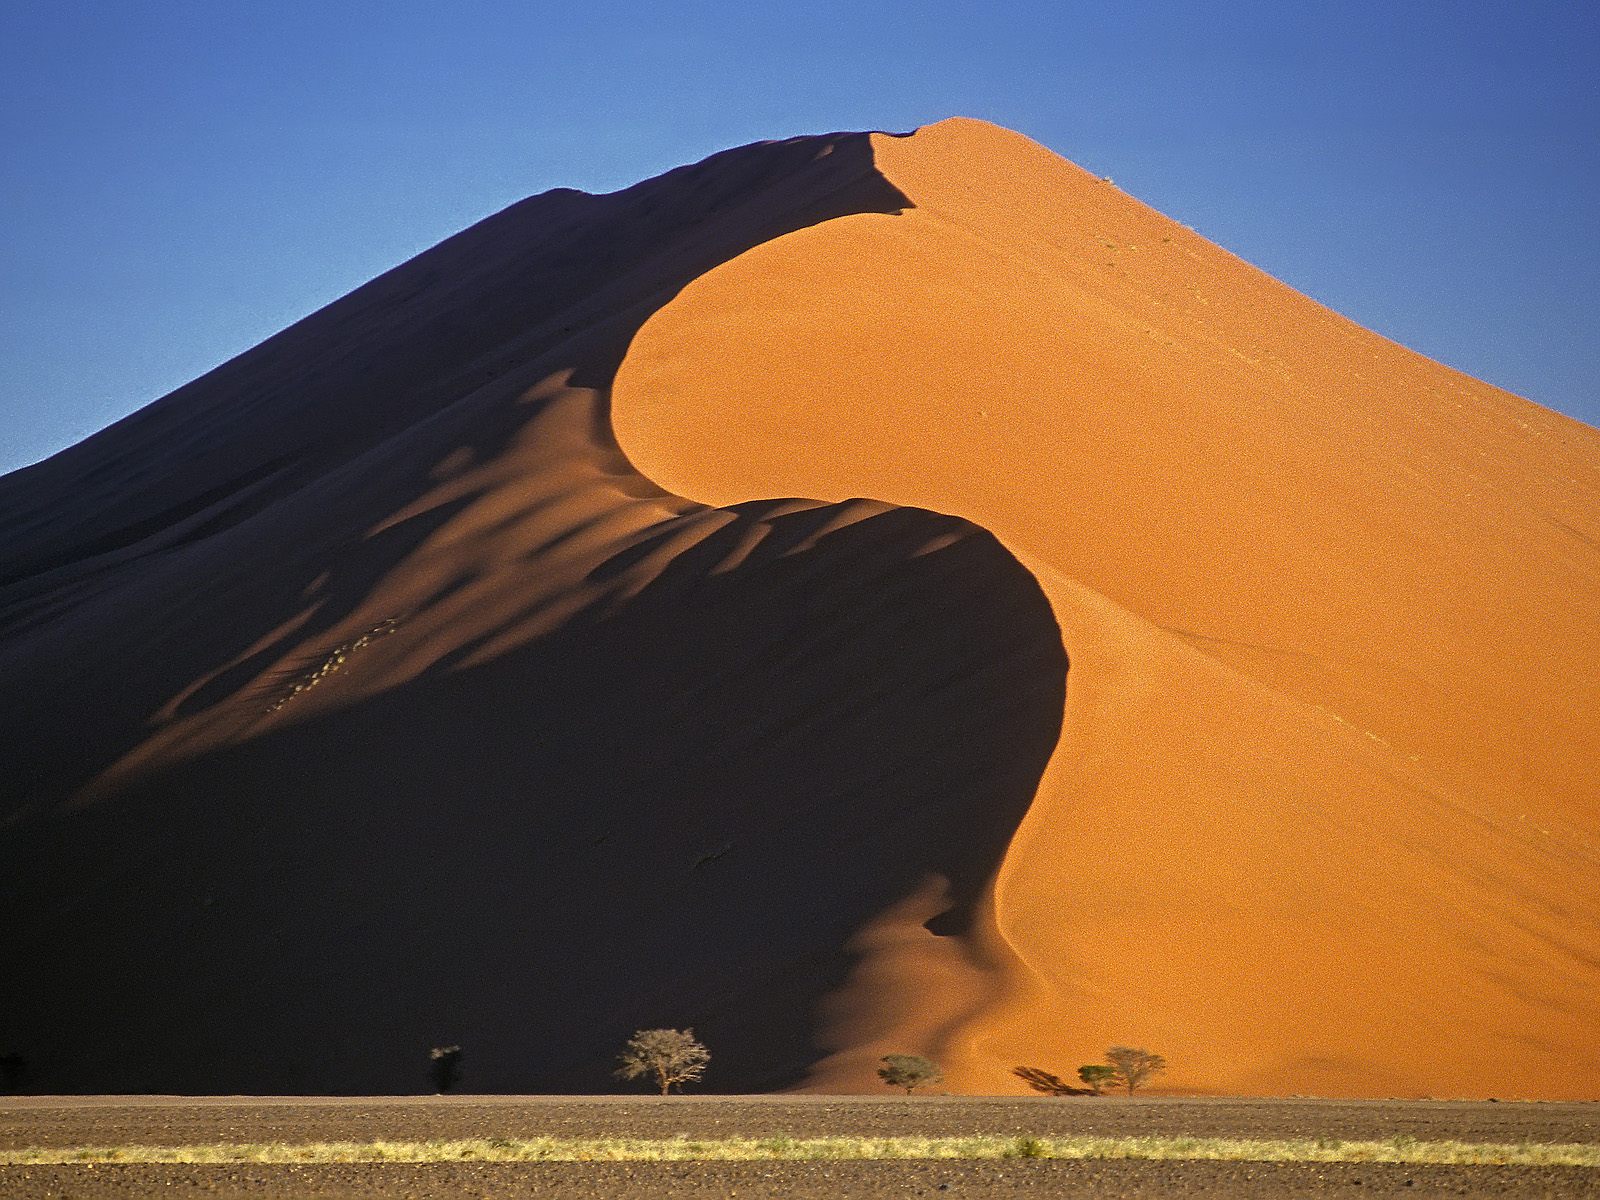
[0, 0, 1600, 470]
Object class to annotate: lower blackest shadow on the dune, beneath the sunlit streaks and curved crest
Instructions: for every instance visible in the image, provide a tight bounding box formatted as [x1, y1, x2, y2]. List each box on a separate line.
[6, 504, 1066, 1093]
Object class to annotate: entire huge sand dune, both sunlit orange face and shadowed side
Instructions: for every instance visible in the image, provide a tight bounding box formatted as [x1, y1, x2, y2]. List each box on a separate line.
[0, 120, 1600, 1098]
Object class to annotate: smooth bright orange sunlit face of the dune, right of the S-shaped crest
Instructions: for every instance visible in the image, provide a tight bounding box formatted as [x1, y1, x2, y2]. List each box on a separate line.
[614, 120, 1600, 1098]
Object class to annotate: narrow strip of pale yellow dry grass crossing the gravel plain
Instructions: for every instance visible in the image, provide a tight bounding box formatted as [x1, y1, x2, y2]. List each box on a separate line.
[0, 1136, 1600, 1166]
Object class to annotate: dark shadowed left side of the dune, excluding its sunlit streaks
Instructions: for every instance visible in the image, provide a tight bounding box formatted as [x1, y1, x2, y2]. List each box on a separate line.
[0, 127, 1066, 1093]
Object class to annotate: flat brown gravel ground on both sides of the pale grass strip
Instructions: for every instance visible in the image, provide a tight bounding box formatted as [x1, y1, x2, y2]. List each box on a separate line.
[0, 1096, 1600, 1200]
